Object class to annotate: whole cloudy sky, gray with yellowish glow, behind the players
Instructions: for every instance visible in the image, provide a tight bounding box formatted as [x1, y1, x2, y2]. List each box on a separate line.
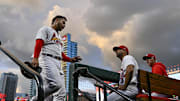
[0, 0, 180, 92]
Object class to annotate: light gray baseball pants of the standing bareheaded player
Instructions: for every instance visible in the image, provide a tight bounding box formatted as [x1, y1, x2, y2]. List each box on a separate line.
[32, 55, 66, 101]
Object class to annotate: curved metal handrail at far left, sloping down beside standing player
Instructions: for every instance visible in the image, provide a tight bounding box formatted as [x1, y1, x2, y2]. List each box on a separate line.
[0, 42, 44, 101]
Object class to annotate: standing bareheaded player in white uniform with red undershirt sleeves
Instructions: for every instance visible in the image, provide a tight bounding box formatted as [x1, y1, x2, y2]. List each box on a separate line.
[31, 15, 81, 101]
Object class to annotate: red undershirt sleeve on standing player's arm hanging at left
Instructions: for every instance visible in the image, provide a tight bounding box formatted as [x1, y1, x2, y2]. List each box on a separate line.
[34, 39, 44, 58]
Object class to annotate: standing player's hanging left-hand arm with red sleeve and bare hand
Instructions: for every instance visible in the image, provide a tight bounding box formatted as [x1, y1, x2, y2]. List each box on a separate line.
[32, 39, 44, 67]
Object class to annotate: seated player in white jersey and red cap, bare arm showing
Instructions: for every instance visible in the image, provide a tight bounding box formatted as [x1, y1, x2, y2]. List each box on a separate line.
[107, 45, 139, 101]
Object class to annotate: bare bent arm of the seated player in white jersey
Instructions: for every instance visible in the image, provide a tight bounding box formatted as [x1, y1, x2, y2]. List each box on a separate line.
[119, 65, 134, 90]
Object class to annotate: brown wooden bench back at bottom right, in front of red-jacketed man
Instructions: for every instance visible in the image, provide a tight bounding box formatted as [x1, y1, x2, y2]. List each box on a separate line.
[136, 70, 180, 101]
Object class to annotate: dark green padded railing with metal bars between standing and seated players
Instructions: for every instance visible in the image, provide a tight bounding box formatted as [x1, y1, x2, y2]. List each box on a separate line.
[69, 64, 134, 101]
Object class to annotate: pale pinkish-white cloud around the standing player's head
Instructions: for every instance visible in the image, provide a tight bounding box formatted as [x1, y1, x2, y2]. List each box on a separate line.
[44, 5, 86, 42]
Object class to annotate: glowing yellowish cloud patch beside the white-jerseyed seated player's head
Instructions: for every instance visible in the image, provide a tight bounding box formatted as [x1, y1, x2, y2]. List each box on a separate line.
[87, 21, 133, 71]
